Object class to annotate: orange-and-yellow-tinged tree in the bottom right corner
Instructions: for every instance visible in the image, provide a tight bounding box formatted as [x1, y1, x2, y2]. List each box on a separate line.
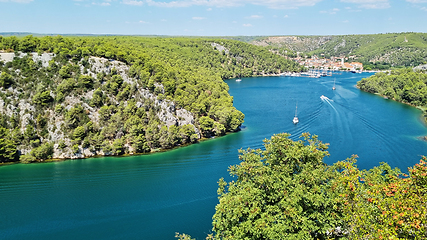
[333, 157, 427, 239]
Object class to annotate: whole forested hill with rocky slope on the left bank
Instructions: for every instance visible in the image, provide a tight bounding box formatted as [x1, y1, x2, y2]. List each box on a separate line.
[0, 35, 302, 162]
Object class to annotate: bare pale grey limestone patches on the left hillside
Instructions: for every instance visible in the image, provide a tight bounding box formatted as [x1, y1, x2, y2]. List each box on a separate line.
[0, 53, 201, 159]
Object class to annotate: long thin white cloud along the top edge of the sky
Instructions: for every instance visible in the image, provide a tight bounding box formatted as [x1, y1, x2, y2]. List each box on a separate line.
[122, 0, 322, 9]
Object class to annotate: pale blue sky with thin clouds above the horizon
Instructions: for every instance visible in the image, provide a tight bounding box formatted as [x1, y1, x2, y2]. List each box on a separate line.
[0, 0, 427, 36]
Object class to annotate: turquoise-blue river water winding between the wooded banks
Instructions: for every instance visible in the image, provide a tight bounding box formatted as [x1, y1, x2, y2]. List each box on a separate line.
[0, 73, 427, 240]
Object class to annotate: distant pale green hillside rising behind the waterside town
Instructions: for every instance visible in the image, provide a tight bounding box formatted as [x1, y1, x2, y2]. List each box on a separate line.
[251, 33, 427, 67]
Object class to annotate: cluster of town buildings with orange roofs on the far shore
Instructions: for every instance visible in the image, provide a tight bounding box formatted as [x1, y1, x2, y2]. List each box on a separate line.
[294, 55, 363, 72]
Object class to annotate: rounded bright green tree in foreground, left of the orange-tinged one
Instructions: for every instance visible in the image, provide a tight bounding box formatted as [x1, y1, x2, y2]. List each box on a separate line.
[213, 133, 343, 239]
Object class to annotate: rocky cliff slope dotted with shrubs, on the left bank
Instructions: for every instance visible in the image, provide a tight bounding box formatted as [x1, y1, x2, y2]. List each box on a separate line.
[0, 53, 201, 159]
